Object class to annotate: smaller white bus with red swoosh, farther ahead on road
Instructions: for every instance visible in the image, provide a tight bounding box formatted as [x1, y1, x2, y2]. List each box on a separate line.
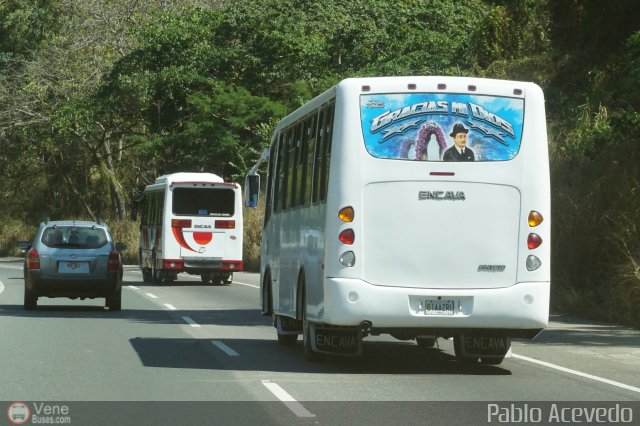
[134, 173, 243, 284]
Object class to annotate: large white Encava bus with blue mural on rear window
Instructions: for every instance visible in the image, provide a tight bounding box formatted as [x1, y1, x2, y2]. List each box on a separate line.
[246, 77, 551, 364]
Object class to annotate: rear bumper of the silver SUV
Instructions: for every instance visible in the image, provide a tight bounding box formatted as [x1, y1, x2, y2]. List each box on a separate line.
[25, 270, 122, 298]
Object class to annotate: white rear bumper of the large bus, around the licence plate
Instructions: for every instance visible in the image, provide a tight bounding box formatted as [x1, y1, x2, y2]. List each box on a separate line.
[318, 278, 550, 338]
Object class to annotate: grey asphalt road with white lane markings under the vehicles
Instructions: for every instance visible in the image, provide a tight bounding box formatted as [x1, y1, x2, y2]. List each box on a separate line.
[0, 259, 640, 425]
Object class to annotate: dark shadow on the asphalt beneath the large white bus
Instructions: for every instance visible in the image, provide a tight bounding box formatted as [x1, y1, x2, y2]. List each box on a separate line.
[130, 338, 511, 376]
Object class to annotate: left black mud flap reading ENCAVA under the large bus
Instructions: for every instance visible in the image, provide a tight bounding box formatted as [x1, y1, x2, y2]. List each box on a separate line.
[309, 323, 362, 356]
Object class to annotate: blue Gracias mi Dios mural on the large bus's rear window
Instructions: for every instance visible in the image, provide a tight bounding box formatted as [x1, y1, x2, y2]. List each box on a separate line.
[360, 93, 524, 161]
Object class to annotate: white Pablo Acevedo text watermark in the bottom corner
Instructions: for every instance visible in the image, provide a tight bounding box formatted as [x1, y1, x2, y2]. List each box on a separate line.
[487, 403, 636, 424]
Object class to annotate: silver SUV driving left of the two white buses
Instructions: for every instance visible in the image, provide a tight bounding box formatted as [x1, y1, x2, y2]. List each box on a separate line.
[18, 220, 126, 311]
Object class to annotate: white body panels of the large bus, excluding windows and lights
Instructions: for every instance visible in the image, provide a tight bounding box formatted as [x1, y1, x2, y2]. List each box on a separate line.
[261, 77, 551, 335]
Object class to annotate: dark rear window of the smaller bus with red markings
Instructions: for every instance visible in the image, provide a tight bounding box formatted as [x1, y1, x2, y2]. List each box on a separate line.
[173, 188, 235, 216]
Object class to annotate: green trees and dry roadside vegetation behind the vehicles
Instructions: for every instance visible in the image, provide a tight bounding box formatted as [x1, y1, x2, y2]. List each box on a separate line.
[0, 0, 640, 327]
